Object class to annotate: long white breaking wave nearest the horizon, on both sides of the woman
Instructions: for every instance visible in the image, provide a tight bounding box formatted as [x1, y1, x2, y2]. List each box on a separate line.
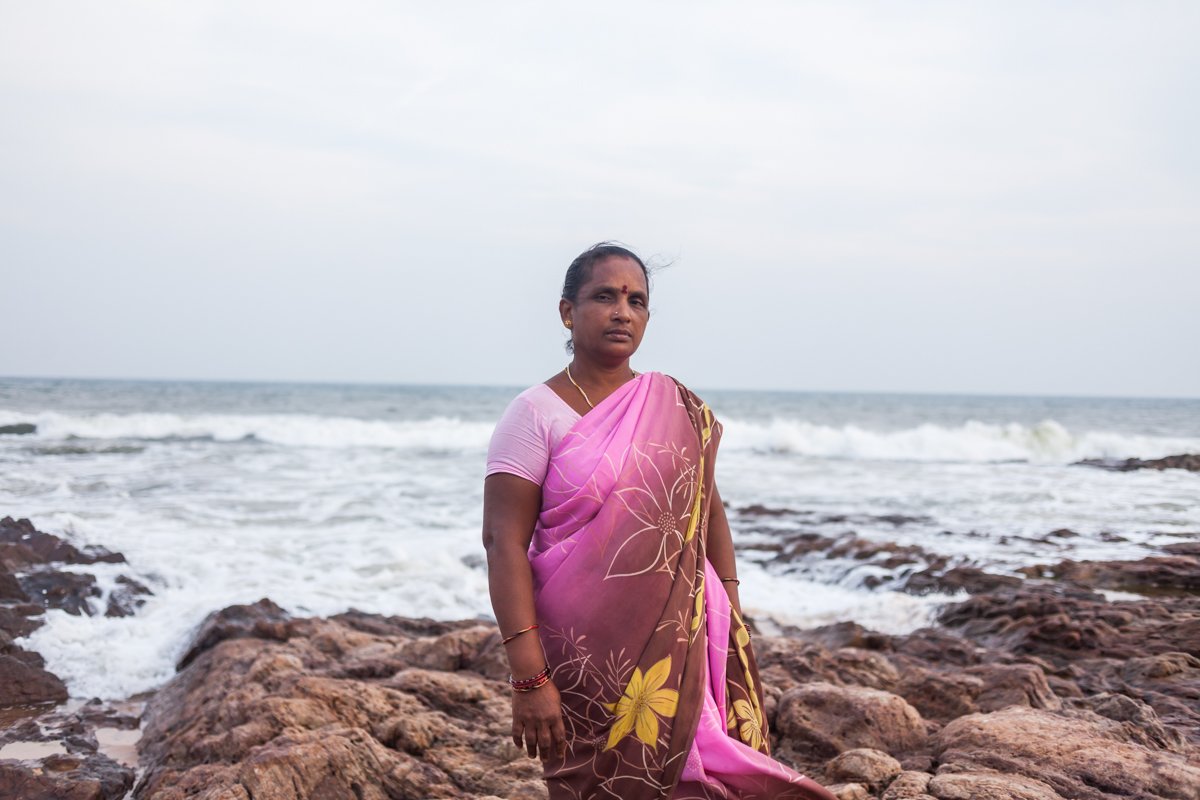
[0, 410, 1200, 463]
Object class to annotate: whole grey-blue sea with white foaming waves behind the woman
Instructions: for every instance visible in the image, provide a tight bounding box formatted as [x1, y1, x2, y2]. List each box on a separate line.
[0, 378, 1200, 699]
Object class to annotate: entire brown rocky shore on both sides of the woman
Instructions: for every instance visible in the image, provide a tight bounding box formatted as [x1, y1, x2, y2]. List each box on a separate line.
[0, 510, 1200, 800]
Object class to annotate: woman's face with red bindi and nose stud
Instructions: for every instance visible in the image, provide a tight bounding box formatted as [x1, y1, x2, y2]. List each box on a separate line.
[559, 255, 650, 361]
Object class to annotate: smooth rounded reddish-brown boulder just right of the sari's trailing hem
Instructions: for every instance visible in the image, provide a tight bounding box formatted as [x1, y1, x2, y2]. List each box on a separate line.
[775, 682, 926, 758]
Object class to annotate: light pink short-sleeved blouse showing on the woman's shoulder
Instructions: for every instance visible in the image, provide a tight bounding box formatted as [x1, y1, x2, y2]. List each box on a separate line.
[487, 384, 580, 486]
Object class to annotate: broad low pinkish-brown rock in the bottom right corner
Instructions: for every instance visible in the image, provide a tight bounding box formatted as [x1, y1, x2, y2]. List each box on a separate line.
[930, 706, 1200, 800]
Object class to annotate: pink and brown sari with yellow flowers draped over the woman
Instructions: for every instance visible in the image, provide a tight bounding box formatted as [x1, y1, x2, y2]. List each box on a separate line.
[529, 373, 833, 800]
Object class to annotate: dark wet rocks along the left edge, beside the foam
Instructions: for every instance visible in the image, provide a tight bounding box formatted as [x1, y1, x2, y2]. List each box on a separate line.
[0, 517, 150, 800]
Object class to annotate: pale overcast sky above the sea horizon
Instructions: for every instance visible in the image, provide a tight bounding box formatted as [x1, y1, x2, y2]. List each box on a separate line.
[0, 0, 1200, 397]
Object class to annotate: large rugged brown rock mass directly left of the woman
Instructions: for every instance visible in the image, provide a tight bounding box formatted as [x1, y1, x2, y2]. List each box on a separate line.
[138, 602, 546, 800]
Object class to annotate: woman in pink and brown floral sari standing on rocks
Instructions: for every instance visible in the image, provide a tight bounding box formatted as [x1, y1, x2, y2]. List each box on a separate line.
[484, 245, 833, 800]
